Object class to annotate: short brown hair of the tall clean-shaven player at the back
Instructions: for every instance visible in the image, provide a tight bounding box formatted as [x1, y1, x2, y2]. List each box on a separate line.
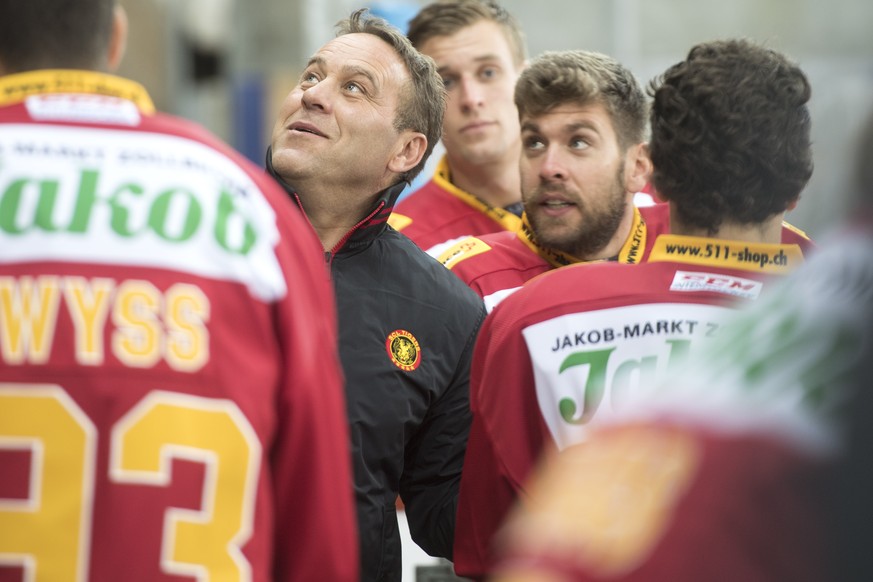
[407, 0, 527, 66]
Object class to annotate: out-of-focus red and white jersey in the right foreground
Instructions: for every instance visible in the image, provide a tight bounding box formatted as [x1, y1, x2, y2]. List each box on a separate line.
[495, 223, 873, 582]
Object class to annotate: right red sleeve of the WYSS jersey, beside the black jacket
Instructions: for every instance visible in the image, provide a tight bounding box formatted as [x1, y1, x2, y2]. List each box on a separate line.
[273, 197, 358, 582]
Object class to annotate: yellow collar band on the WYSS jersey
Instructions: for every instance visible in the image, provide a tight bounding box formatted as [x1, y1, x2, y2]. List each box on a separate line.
[0, 69, 155, 115]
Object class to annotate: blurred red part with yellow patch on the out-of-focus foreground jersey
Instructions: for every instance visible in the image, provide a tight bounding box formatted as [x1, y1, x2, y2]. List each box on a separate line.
[494, 420, 827, 582]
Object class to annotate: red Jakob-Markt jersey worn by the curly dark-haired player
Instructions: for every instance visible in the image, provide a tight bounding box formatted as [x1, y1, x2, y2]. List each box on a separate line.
[454, 235, 803, 578]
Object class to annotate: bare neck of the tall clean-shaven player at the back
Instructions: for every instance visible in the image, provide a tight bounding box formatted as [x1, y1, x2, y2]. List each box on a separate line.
[449, 158, 521, 208]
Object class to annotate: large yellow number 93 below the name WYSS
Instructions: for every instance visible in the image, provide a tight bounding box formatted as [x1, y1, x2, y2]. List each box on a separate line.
[0, 383, 263, 582]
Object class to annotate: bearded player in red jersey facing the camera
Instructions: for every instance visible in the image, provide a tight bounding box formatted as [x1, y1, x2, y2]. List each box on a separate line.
[439, 51, 812, 311]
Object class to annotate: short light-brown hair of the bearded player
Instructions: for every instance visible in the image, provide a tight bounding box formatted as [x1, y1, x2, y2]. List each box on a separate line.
[515, 50, 648, 149]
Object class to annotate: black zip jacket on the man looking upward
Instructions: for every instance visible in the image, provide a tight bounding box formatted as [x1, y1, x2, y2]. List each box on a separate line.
[267, 154, 485, 582]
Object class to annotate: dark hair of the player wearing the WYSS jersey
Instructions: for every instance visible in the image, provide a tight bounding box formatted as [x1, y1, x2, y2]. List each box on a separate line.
[0, 0, 116, 74]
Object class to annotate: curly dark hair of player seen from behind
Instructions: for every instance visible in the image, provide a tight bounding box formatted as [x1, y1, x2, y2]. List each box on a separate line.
[649, 40, 812, 232]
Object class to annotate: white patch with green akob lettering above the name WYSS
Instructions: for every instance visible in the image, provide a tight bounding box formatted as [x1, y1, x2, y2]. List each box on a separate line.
[0, 125, 287, 301]
